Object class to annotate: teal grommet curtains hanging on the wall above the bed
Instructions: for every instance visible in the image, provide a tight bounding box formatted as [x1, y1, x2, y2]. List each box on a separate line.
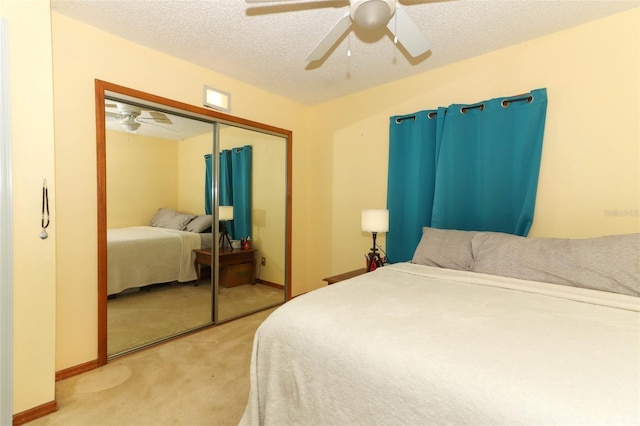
[387, 89, 547, 262]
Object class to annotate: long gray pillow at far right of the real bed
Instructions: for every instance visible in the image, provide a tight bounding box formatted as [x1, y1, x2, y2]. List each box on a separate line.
[471, 232, 640, 296]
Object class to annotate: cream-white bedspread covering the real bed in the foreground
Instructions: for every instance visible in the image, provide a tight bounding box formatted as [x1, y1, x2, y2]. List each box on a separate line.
[241, 263, 640, 425]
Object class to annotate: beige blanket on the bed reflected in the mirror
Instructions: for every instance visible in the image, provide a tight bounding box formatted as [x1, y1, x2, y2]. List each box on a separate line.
[107, 226, 200, 295]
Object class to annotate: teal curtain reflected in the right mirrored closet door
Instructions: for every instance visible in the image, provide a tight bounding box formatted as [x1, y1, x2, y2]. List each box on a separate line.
[218, 145, 252, 240]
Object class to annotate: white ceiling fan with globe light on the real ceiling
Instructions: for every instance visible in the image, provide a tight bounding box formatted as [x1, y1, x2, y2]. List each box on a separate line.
[246, 0, 431, 61]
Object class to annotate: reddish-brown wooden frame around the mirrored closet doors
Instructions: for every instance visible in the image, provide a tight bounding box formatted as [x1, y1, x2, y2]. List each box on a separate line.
[95, 79, 293, 366]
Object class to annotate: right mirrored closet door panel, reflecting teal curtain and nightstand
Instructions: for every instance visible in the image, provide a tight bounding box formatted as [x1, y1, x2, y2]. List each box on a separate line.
[217, 126, 287, 320]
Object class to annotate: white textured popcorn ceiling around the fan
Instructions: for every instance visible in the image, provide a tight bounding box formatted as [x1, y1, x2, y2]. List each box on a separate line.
[51, 0, 640, 105]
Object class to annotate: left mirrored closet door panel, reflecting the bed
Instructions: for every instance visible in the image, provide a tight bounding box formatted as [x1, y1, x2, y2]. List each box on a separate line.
[105, 98, 213, 356]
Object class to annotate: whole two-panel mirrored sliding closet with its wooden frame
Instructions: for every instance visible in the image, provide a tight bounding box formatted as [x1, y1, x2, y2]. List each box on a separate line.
[96, 81, 291, 365]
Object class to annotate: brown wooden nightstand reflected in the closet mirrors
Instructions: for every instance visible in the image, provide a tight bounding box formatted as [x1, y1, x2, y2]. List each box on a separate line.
[193, 249, 256, 287]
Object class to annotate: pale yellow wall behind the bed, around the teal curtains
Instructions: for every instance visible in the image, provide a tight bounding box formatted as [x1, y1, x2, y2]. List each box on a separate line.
[312, 8, 640, 275]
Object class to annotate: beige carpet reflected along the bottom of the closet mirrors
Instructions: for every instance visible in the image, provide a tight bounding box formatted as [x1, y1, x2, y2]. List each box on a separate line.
[107, 282, 284, 355]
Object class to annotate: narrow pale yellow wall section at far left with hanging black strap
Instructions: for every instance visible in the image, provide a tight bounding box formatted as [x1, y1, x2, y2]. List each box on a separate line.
[0, 0, 58, 418]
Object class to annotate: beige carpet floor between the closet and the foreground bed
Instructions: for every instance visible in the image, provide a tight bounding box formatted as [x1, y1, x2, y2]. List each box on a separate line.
[29, 308, 274, 426]
